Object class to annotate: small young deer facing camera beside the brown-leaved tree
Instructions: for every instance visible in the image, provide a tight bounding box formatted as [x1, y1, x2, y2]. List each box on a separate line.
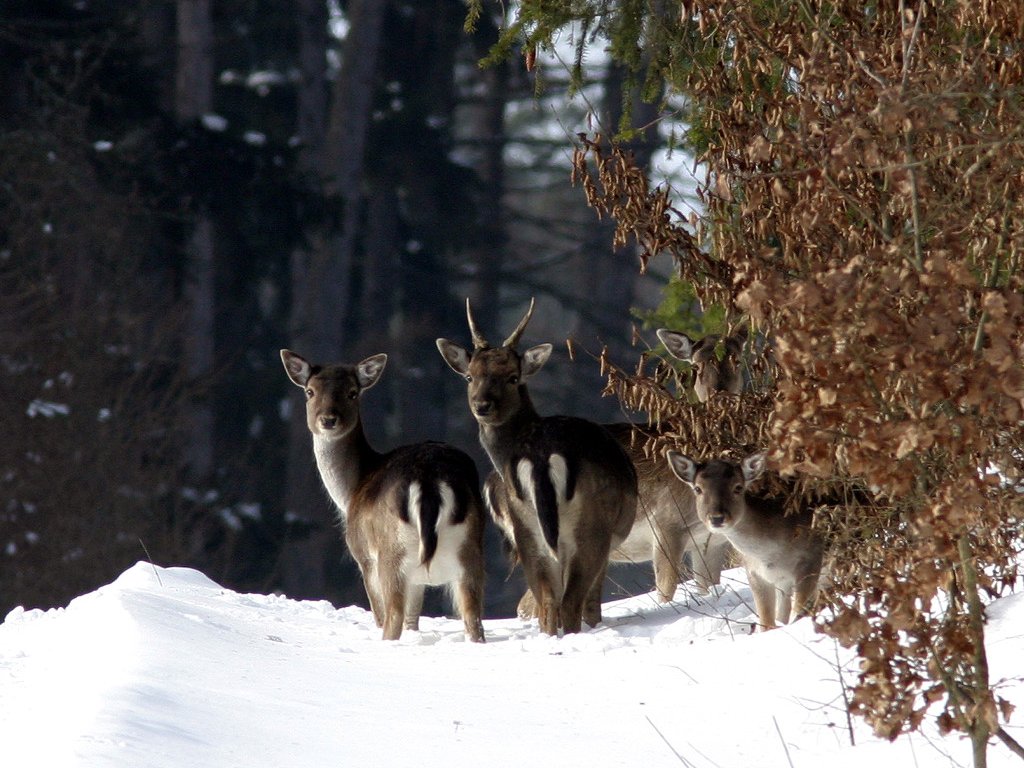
[668, 451, 824, 630]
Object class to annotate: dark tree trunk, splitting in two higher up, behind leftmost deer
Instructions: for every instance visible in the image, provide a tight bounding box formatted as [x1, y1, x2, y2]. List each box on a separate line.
[282, 0, 388, 597]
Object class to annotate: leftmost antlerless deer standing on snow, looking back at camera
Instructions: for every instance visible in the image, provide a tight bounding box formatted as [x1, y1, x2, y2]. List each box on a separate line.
[281, 349, 483, 642]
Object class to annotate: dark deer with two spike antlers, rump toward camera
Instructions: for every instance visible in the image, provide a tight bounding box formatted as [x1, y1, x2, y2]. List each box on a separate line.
[437, 300, 637, 635]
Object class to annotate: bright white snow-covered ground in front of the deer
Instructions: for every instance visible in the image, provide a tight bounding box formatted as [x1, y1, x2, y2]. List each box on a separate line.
[0, 563, 1024, 768]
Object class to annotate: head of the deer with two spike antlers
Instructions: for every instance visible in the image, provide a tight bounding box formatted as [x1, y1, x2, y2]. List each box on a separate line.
[437, 299, 552, 426]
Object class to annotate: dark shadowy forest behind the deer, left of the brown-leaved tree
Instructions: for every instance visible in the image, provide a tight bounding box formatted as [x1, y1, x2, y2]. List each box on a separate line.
[0, 0, 688, 613]
